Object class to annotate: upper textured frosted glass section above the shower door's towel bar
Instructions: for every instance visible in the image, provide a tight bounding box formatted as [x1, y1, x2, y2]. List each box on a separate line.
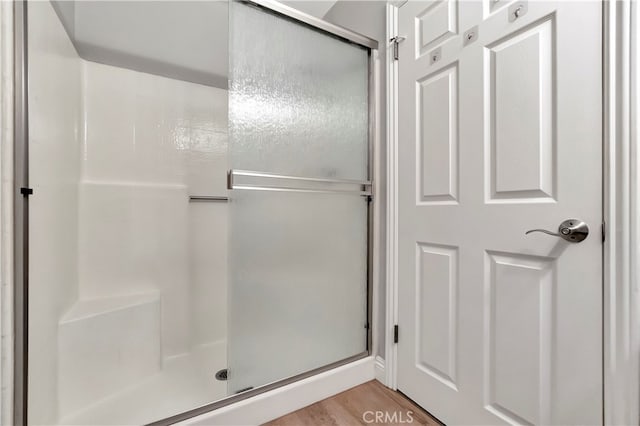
[229, 1, 369, 180]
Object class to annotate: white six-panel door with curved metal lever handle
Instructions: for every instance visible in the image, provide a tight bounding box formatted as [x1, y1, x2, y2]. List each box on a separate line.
[398, 0, 603, 425]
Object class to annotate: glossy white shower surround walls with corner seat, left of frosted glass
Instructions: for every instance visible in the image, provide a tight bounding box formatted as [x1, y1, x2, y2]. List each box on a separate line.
[29, 2, 227, 424]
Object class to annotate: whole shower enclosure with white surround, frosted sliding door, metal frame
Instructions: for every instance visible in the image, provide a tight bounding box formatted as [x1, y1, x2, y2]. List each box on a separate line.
[15, 0, 377, 424]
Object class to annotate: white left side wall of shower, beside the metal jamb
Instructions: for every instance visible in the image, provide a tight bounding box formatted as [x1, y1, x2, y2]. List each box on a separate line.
[28, 2, 82, 424]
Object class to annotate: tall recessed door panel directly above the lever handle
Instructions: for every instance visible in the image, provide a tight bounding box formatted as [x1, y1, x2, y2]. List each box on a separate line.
[485, 17, 556, 202]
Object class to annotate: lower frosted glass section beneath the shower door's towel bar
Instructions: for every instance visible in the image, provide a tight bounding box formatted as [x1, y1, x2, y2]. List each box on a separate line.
[229, 191, 367, 393]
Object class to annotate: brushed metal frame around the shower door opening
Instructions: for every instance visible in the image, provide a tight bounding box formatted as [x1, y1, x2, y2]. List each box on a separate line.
[12, 0, 379, 426]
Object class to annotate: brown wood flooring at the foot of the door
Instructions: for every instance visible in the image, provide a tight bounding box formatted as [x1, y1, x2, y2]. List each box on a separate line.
[266, 380, 441, 426]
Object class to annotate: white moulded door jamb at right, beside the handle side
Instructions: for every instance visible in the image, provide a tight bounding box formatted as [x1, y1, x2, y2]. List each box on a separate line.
[603, 0, 640, 424]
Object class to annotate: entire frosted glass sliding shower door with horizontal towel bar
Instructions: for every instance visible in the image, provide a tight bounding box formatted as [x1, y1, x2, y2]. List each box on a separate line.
[228, 1, 370, 394]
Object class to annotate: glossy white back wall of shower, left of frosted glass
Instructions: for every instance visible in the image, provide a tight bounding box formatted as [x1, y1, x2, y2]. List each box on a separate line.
[80, 61, 227, 356]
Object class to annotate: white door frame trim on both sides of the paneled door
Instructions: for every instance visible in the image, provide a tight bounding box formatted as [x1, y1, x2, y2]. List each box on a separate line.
[383, 0, 640, 424]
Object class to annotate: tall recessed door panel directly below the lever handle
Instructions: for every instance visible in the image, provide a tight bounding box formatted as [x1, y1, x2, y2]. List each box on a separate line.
[483, 252, 556, 424]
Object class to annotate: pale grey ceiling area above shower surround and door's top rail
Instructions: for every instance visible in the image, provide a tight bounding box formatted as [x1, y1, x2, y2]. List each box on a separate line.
[52, 0, 336, 88]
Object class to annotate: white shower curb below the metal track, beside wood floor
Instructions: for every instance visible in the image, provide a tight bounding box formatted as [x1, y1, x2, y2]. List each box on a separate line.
[177, 356, 376, 426]
